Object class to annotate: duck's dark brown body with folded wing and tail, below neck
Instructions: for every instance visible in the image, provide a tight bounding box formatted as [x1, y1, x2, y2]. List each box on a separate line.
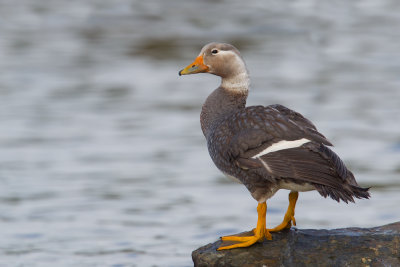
[207, 105, 365, 202]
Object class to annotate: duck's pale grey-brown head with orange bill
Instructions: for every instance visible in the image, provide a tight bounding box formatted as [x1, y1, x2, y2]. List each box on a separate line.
[179, 43, 247, 79]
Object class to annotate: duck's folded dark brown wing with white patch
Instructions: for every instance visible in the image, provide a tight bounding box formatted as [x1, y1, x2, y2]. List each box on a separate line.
[225, 105, 366, 202]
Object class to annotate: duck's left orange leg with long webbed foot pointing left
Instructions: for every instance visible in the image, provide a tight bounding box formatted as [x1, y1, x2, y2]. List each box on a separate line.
[218, 202, 271, 250]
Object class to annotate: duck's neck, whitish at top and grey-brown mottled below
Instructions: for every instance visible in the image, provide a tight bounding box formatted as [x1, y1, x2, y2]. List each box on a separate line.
[200, 72, 250, 138]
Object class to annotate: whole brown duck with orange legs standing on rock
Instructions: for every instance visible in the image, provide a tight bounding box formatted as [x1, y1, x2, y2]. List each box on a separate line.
[179, 42, 370, 250]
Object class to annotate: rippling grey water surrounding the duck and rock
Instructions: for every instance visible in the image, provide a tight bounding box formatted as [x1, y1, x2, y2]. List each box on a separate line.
[0, 0, 400, 266]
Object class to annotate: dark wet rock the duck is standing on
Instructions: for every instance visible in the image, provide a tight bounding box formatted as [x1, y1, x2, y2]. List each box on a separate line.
[192, 222, 400, 267]
